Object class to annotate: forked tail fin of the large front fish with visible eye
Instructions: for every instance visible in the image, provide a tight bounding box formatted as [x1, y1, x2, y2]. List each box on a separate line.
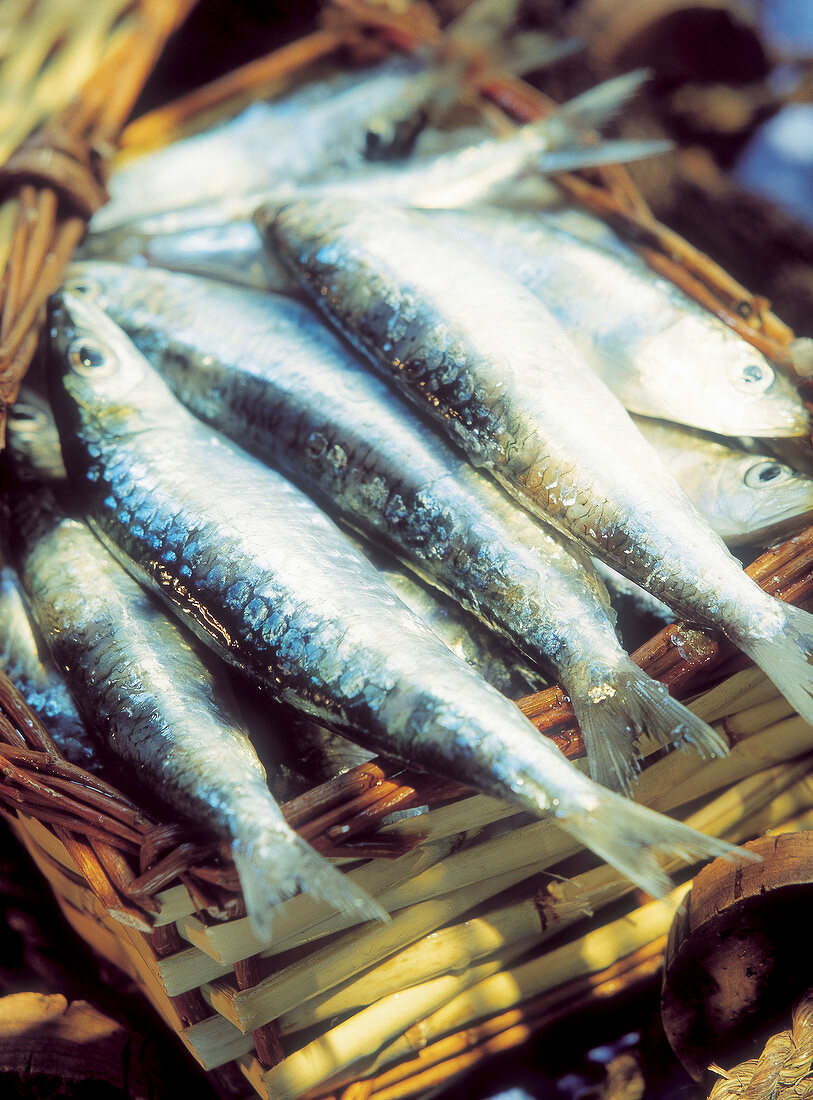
[557, 785, 755, 898]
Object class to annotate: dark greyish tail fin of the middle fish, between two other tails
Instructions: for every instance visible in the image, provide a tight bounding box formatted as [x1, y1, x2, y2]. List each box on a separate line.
[571, 659, 728, 792]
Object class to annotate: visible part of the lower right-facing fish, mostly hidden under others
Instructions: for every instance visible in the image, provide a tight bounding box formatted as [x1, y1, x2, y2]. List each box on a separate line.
[635, 417, 813, 546]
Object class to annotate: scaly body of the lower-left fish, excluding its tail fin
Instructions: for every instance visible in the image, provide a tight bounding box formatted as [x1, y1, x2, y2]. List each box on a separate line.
[15, 503, 285, 838]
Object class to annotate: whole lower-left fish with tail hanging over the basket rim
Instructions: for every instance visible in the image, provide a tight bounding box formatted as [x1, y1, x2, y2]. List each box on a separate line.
[7, 487, 385, 938]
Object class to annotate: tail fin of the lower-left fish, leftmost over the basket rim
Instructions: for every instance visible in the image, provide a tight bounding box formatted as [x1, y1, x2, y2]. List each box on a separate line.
[232, 825, 389, 941]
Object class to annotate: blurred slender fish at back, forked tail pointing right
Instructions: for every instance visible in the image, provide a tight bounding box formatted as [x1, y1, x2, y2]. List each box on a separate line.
[83, 73, 671, 257]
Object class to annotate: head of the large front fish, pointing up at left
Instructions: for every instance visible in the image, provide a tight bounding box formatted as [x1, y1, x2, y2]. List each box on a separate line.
[48, 290, 174, 447]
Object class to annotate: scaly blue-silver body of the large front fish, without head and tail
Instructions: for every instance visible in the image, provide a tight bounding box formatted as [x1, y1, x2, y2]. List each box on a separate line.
[55, 352, 593, 812]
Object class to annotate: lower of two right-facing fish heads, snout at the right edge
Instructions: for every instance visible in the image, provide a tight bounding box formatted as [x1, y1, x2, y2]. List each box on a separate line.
[708, 454, 813, 546]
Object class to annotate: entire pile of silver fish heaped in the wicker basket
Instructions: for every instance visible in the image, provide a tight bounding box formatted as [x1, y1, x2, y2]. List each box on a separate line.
[0, 38, 813, 937]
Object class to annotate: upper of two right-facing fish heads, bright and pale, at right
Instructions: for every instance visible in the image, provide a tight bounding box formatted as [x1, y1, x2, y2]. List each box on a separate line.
[636, 312, 811, 438]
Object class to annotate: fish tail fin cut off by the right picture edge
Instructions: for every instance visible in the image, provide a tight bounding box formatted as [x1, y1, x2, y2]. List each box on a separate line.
[732, 595, 813, 725]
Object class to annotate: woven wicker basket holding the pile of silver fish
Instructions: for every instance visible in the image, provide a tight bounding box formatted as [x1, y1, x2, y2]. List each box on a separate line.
[0, 0, 813, 1100]
